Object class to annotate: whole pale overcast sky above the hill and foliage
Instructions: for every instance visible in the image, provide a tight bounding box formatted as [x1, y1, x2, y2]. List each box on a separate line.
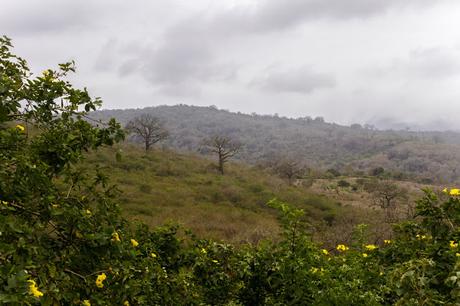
[0, 0, 460, 129]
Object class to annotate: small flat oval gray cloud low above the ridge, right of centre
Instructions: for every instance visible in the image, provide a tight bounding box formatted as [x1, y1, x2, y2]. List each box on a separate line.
[252, 67, 336, 94]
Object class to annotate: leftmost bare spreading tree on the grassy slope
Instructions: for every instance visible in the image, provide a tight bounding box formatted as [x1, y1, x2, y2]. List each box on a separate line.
[126, 114, 169, 151]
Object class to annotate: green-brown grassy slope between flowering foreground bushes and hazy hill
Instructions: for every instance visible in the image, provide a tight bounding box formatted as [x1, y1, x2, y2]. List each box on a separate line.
[79, 144, 432, 245]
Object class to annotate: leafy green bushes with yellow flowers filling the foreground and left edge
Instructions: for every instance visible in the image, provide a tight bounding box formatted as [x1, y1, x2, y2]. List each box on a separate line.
[0, 38, 460, 305]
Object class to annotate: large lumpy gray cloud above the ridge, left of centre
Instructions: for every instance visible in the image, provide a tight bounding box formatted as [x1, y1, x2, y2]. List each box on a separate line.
[114, 21, 237, 96]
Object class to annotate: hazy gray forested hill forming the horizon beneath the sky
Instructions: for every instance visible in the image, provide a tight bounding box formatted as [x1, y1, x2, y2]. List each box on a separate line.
[91, 105, 460, 183]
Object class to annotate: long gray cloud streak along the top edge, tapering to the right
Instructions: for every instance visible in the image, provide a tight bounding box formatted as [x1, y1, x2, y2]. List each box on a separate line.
[196, 0, 444, 36]
